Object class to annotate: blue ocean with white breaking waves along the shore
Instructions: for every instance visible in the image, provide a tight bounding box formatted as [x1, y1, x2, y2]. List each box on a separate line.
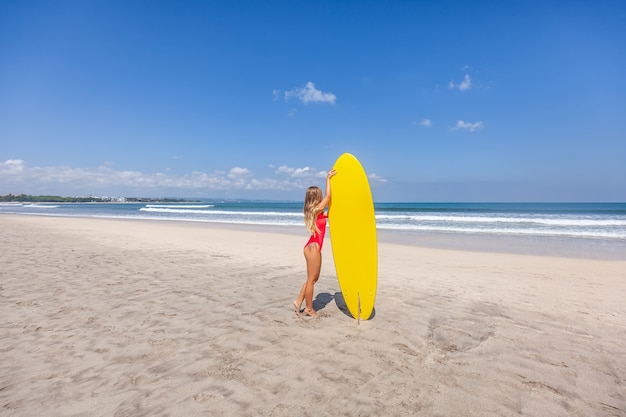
[0, 200, 626, 258]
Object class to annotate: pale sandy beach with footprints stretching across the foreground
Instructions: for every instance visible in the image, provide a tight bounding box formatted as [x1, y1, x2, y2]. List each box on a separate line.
[0, 215, 626, 416]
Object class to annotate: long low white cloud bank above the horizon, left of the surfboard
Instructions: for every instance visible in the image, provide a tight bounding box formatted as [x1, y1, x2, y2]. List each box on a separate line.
[0, 159, 342, 197]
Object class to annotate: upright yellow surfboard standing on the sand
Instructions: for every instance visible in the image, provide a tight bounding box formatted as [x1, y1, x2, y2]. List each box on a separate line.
[328, 153, 378, 320]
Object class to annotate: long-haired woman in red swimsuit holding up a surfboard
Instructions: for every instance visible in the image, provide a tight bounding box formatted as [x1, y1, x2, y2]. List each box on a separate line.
[293, 169, 336, 317]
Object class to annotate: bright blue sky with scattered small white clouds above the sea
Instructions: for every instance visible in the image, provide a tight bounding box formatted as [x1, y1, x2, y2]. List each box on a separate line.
[0, 0, 626, 202]
